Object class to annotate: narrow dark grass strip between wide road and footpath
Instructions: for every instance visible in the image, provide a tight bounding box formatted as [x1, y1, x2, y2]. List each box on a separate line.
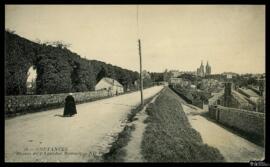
[102, 94, 160, 162]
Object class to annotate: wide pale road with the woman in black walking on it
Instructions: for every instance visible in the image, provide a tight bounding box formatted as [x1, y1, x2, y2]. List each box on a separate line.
[5, 86, 163, 162]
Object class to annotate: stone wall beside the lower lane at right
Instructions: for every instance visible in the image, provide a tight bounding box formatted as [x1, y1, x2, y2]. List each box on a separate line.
[209, 105, 265, 137]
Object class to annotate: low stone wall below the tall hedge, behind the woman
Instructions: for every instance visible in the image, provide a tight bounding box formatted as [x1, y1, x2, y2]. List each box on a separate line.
[5, 90, 110, 116]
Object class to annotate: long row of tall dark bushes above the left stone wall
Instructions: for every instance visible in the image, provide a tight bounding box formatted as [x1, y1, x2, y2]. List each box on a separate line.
[5, 31, 139, 95]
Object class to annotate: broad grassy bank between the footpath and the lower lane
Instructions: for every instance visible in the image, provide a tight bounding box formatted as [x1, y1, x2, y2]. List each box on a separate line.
[141, 88, 224, 162]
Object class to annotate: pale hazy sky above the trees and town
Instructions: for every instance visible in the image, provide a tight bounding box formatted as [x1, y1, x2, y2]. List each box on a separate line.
[5, 5, 265, 74]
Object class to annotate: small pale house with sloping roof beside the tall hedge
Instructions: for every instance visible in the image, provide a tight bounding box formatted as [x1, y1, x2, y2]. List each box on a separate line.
[95, 77, 124, 95]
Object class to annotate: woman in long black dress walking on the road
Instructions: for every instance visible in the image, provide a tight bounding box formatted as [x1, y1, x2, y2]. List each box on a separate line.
[63, 93, 77, 117]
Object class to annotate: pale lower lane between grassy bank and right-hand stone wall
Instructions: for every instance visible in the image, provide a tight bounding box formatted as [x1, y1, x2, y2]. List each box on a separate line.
[182, 104, 264, 162]
